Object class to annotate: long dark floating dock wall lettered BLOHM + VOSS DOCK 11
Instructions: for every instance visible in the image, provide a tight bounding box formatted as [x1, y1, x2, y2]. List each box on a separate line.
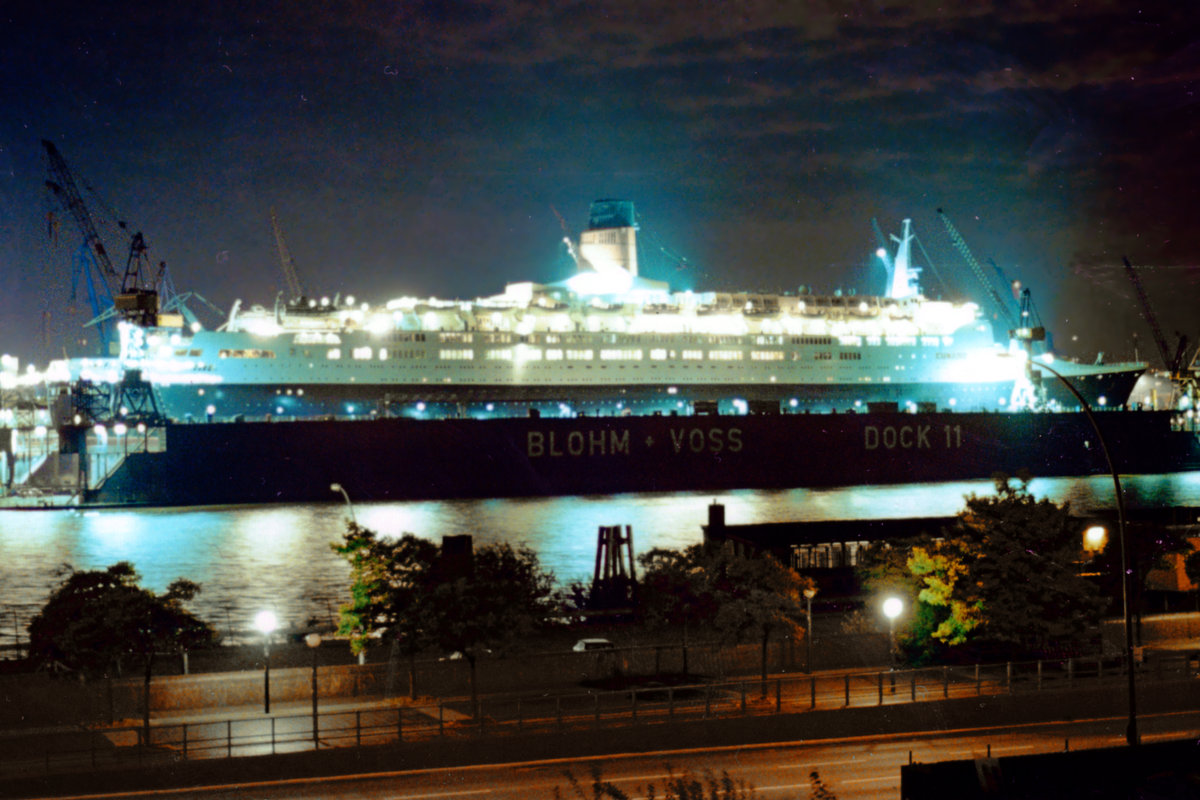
[85, 411, 1200, 506]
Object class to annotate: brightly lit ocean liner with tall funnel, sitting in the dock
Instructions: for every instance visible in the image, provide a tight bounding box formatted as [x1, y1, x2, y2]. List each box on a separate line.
[49, 200, 1147, 422]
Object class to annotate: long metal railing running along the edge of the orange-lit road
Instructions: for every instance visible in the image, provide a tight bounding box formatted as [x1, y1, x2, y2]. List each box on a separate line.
[7, 654, 1200, 777]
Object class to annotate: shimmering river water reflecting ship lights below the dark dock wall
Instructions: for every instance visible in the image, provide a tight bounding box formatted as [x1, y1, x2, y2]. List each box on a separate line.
[0, 473, 1200, 643]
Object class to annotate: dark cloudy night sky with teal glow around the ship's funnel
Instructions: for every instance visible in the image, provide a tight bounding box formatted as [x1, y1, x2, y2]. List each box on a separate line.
[0, 0, 1200, 363]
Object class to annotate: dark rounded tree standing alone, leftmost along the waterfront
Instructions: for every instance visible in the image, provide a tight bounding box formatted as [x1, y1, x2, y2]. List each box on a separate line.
[29, 561, 215, 741]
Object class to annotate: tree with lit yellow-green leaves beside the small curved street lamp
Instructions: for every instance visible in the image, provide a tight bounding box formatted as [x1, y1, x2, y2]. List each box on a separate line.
[331, 521, 438, 698]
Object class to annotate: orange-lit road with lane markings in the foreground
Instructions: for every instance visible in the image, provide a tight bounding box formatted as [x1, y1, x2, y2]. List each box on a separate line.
[32, 711, 1200, 800]
